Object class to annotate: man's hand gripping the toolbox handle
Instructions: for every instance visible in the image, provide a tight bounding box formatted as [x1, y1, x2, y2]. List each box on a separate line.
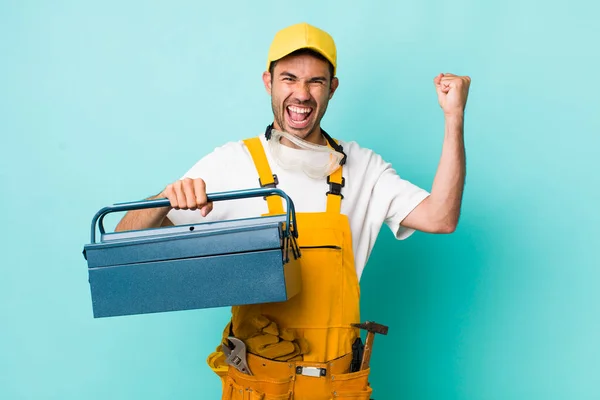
[162, 178, 213, 217]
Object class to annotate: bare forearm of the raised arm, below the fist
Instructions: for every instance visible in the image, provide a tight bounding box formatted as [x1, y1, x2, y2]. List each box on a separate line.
[428, 113, 466, 232]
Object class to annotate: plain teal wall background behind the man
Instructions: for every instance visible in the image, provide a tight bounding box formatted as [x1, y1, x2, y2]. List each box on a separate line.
[0, 0, 600, 400]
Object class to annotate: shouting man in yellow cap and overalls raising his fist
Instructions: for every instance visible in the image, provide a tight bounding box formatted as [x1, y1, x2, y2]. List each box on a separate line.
[117, 23, 470, 400]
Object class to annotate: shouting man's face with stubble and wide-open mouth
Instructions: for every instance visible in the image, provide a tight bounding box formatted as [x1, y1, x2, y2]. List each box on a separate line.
[263, 54, 339, 144]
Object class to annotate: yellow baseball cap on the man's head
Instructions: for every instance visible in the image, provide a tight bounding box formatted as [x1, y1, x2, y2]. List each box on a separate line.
[267, 22, 337, 76]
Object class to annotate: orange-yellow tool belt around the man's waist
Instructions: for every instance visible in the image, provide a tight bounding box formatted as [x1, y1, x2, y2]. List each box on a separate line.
[221, 354, 372, 400]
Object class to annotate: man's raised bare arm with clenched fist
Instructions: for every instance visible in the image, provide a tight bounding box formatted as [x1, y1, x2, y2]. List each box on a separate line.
[400, 74, 471, 233]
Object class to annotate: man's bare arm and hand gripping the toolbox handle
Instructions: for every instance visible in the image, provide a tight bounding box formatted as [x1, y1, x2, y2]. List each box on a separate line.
[115, 178, 213, 232]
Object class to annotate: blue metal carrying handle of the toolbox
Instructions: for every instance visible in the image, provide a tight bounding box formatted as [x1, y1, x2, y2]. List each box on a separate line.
[90, 188, 298, 243]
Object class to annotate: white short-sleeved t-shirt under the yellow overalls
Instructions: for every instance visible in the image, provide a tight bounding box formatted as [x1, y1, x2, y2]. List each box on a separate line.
[168, 135, 429, 279]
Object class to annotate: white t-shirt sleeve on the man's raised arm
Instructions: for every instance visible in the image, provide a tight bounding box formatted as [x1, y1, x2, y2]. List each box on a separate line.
[373, 156, 429, 240]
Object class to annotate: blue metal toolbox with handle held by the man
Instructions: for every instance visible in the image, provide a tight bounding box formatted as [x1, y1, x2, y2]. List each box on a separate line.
[83, 188, 301, 318]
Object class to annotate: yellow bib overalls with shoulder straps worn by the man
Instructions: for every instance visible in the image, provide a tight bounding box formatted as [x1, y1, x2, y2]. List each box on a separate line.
[207, 137, 372, 400]
